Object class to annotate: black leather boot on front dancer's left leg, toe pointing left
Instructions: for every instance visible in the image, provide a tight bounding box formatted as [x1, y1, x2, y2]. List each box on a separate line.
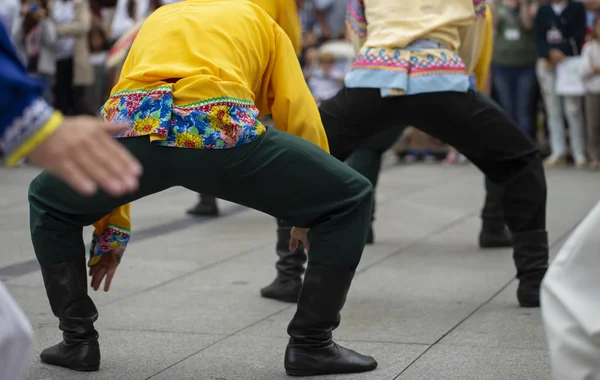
[40, 255, 100, 371]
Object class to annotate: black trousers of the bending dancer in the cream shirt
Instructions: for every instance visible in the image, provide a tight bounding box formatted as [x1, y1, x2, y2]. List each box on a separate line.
[319, 88, 547, 232]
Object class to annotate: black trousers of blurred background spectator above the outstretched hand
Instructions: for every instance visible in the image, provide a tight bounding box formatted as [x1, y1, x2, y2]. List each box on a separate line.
[54, 58, 85, 115]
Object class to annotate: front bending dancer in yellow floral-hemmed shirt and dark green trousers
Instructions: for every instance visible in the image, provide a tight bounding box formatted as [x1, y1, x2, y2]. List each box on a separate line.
[29, 0, 377, 375]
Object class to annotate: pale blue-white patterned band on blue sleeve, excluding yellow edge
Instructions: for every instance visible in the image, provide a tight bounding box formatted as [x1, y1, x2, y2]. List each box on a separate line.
[0, 98, 54, 156]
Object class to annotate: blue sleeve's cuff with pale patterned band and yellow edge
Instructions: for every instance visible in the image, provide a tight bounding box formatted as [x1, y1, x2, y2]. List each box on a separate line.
[1, 98, 63, 166]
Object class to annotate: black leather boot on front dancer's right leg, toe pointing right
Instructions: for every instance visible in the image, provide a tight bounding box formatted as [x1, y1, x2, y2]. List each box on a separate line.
[284, 264, 377, 376]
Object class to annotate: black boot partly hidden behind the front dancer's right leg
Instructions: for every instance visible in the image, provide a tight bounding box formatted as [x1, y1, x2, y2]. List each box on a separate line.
[260, 220, 307, 302]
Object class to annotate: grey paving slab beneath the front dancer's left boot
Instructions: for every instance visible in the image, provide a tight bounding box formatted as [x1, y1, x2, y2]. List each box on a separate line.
[25, 328, 223, 380]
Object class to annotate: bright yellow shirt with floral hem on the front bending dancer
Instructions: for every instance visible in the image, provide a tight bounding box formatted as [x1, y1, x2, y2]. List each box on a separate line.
[94, 0, 329, 265]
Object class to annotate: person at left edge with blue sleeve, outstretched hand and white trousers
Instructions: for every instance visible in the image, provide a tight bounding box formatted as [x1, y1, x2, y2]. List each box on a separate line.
[0, 22, 140, 380]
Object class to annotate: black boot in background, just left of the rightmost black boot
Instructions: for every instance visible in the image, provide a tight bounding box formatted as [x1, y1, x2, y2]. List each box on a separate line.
[479, 195, 512, 248]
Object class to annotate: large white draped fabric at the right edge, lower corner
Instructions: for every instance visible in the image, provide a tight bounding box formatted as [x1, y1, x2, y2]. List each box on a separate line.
[541, 202, 600, 380]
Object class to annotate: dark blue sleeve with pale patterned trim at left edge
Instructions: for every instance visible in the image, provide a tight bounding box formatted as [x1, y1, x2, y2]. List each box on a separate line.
[0, 23, 54, 160]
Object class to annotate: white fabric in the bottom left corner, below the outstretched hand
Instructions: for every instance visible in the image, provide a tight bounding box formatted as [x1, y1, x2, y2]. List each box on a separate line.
[0, 283, 33, 380]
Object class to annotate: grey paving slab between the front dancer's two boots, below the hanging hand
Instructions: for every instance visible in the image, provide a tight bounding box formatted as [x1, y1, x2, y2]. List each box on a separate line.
[97, 251, 294, 334]
